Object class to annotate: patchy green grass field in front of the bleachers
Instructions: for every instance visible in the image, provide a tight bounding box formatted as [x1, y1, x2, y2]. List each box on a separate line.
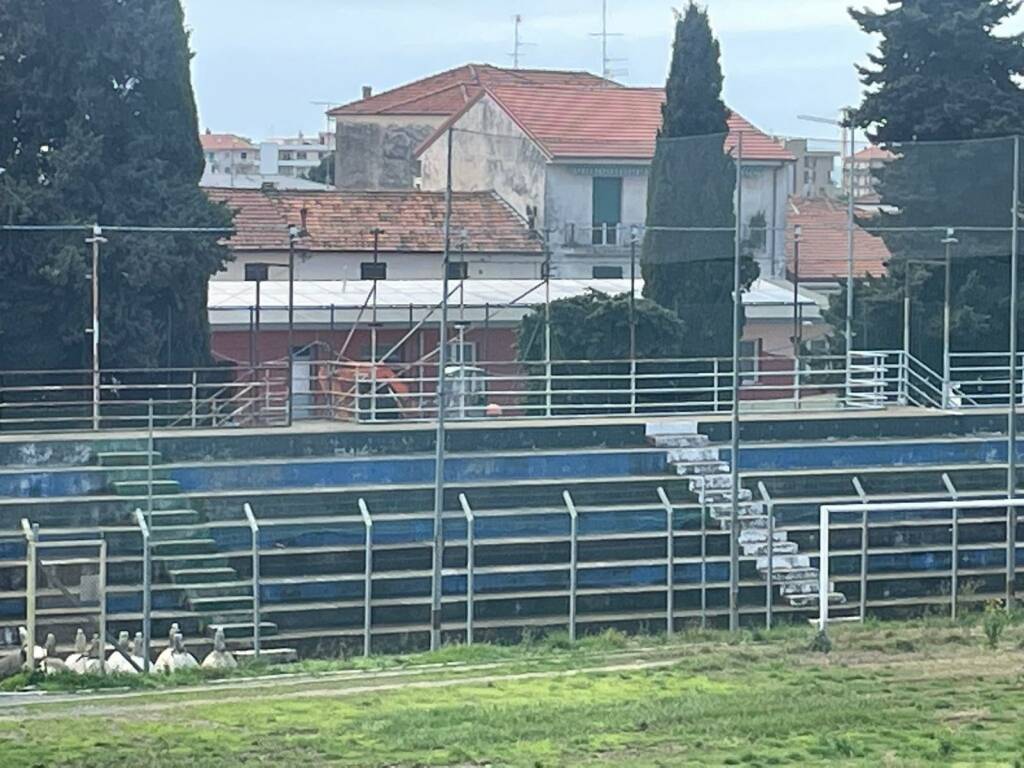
[0, 620, 1024, 768]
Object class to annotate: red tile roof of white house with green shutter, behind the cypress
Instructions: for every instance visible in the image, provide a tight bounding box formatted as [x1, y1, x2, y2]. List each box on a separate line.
[417, 86, 794, 162]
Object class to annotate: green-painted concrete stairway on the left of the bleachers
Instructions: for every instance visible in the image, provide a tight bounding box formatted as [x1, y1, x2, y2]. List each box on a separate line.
[96, 451, 278, 639]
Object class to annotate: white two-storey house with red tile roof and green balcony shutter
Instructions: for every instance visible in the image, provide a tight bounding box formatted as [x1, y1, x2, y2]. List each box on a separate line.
[416, 84, 796, 279]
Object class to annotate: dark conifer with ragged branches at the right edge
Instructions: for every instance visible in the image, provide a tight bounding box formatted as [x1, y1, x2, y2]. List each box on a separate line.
[826, 0, 1024, 368]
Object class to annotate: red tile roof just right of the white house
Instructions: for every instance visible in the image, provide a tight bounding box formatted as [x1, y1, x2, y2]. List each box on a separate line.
[785, 198, 891, 281]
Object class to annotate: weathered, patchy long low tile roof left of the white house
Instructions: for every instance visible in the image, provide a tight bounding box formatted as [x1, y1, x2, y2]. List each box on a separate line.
[206, 188, 543, 254]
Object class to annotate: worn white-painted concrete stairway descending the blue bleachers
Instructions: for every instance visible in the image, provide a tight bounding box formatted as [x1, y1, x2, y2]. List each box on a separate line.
[646, 421, 846, 608]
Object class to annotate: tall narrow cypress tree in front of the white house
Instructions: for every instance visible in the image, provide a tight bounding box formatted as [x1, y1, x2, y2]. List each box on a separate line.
[642, 3, 758, 356]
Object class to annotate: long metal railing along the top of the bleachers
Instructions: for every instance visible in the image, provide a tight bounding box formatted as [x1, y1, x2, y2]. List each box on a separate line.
[0, 350, 1024, 432]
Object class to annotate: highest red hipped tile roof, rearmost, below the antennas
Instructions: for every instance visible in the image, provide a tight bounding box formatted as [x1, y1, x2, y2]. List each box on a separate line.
[328, 65, 618, 117]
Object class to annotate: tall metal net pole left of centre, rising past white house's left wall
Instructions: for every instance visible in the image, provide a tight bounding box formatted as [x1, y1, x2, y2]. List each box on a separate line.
[430, 127, 455, 650]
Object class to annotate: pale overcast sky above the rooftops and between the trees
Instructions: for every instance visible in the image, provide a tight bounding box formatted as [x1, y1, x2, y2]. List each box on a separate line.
[183, 0, 1015, 144]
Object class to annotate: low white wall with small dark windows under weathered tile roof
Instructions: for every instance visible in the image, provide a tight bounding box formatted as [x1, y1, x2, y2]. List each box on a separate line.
[213, 251, 548, 281]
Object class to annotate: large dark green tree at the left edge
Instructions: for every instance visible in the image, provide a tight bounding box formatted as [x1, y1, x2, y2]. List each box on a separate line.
[0, 0, 230, 369]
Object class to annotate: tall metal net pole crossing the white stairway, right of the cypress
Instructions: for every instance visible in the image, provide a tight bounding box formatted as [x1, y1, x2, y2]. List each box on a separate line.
[729, 131, 743, 632]
